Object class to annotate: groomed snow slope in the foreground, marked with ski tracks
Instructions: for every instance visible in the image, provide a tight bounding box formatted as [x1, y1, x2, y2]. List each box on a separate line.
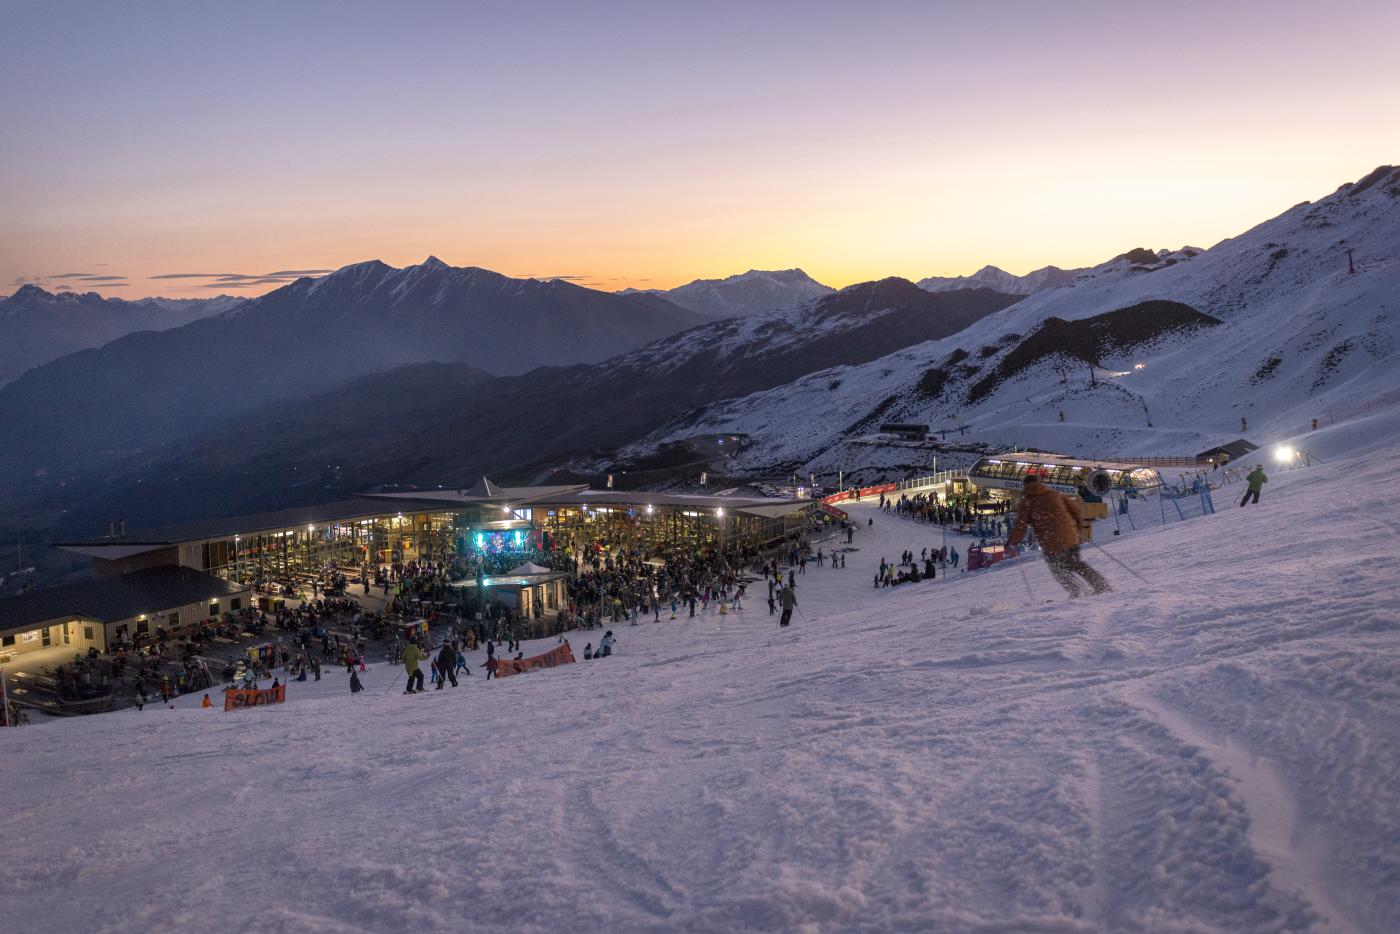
[0, 416, 1400, 933]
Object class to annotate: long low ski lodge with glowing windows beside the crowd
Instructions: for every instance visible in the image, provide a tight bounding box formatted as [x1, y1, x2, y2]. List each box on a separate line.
[0, 478, 816, 649]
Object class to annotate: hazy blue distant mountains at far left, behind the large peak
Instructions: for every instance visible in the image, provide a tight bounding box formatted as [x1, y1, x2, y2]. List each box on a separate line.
[0, 286, 244, 385]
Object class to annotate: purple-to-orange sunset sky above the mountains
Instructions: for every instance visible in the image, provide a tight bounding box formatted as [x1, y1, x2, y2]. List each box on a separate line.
[0, 0, 1400, 297]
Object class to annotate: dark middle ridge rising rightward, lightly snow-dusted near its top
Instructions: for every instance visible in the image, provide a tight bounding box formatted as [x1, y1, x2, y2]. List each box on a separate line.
[30, 279, 1018, 527]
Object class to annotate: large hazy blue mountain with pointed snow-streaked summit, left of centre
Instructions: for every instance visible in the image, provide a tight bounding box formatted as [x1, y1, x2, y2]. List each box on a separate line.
[0, 258, 703, 466]
